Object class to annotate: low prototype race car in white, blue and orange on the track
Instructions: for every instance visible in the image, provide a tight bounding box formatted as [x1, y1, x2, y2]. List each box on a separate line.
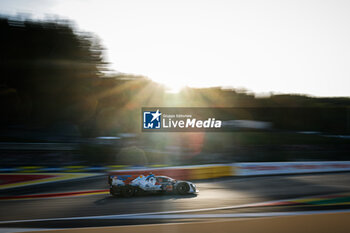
[108, 174, 198, 197]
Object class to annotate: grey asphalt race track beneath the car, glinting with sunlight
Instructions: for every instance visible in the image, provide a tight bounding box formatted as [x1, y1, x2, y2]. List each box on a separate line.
[0, 173, 350, 228]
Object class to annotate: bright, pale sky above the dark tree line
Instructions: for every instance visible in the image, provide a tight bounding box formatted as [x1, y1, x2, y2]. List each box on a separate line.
[0, 0, 350, 96]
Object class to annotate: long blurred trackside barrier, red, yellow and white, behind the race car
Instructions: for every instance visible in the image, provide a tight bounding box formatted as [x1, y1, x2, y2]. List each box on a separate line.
[0, 161, 350, 180]
